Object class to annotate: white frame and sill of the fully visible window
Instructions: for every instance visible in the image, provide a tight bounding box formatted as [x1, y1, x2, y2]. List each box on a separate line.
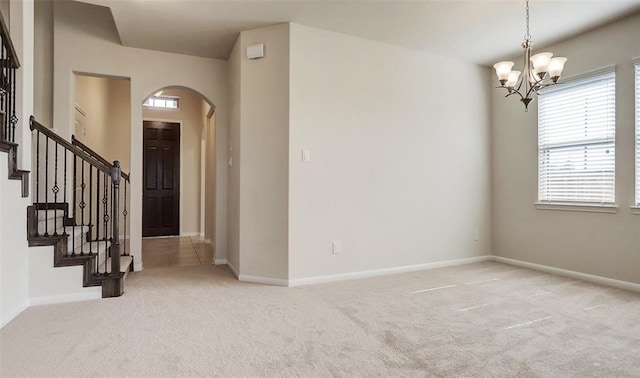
[534, 66, 618, 213]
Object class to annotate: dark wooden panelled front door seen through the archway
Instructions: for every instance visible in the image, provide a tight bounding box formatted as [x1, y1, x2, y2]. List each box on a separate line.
[142, 121, 180, 236]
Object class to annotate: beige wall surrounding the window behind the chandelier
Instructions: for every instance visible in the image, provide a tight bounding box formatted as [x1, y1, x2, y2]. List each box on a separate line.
[491, 14, 640, 283]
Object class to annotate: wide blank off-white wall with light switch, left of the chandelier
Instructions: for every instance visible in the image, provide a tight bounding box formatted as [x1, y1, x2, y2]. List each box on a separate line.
[288, 24, 491, 280]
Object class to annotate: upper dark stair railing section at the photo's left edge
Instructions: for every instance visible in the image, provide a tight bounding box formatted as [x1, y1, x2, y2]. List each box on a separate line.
[0, 13, 20, 143]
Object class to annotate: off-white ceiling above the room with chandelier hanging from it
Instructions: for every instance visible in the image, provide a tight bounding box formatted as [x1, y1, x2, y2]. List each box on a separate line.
[83, 0, 640, 64]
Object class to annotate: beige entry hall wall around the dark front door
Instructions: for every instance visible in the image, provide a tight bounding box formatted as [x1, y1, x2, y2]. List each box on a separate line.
[138, 88, 208, 236]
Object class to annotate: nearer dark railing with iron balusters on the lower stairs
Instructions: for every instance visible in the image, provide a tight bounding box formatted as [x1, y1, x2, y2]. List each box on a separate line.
[27, 116, 126, 282]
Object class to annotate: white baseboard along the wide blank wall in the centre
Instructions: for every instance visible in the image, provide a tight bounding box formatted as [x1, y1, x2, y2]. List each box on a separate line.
[288, 255, 491, 286]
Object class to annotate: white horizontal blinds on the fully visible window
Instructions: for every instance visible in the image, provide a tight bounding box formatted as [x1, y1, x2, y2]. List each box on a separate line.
[538, 69, 616, 204]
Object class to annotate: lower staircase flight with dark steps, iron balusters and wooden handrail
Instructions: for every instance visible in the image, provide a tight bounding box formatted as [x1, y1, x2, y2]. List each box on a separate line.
[27, 117, 133, 298]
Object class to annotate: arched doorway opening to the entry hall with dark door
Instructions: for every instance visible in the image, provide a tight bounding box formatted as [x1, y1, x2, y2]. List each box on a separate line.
[140, 86, 215, 269]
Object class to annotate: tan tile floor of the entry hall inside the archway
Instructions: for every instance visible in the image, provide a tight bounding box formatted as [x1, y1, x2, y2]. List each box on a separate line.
[142, 236, 213, 269]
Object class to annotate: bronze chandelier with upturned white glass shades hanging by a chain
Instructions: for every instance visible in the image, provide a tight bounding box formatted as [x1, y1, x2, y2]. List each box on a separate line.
[493, 0, 567, 111]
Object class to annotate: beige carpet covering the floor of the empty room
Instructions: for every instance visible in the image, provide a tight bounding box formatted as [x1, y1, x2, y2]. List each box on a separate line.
[0, 263, 640, 377]
